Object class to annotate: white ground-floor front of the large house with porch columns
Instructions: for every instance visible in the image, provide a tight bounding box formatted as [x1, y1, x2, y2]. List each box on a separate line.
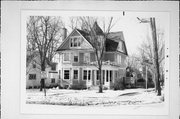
[59, 67, 125, 89]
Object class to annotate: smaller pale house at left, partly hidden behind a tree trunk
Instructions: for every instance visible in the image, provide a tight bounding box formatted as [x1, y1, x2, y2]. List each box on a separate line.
[26, 52, 59, 88]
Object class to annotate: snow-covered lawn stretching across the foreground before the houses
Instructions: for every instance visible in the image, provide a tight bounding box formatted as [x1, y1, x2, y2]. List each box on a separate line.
[26, 89, 163, 106]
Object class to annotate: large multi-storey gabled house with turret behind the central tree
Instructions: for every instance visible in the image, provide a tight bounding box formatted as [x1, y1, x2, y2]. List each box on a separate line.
[57, 24, 128, 88]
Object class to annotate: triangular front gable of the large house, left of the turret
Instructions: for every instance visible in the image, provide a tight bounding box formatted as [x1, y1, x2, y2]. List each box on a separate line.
[57, 29, 92, 51]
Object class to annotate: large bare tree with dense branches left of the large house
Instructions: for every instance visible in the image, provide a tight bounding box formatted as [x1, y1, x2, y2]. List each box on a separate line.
[27, 16, 63, 90]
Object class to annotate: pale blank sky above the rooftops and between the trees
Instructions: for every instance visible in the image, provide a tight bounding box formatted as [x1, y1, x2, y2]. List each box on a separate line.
[59, 12, 168, 55]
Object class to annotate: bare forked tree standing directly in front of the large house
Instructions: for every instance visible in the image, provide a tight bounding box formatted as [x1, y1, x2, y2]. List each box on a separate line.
[79, 17, 113, 93]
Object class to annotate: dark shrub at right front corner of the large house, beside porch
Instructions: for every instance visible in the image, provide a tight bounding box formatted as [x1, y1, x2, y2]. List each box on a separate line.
[113, 78, 124, 90]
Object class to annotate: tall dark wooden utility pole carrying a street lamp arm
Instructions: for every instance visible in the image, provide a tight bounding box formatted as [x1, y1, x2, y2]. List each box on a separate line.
[150, 18, 161, 95]
